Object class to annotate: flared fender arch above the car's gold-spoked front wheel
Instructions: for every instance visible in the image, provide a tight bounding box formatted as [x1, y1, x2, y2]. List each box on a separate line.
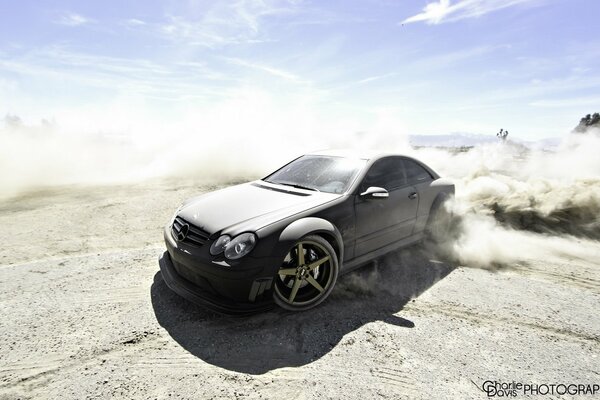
[279, 217, 344, 265]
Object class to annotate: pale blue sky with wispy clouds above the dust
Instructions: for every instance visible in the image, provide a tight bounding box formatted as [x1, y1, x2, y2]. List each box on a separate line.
[0, 0, 600, 140]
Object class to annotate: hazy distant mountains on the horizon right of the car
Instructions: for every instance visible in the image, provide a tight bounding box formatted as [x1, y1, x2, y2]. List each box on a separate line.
[408, 132, 561, 148]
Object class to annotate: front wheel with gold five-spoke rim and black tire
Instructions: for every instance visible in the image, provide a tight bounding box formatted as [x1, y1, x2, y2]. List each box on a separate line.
[273, 235, 339, 311]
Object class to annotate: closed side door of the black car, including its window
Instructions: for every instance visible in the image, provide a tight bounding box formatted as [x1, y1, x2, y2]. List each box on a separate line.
[354, 157, 419, 257]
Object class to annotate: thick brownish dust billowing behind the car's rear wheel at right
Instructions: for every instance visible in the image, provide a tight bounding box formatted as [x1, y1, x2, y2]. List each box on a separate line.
[414, 131, 600, 268]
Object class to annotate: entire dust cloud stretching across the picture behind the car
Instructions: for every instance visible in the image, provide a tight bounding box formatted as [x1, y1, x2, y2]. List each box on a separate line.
[0, 92, 600, 268]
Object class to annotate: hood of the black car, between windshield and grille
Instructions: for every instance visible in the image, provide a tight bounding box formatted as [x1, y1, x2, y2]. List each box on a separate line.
[178, 181, 340, 235]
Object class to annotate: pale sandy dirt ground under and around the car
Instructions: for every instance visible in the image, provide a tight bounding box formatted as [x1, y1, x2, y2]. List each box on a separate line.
[0, 182, 600, 399]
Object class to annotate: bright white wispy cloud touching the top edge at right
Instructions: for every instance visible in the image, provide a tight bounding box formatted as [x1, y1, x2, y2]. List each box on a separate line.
[402, 0, 540, 25]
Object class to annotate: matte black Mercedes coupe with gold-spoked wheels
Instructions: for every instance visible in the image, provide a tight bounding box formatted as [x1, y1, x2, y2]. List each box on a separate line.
[160, 151, 454, 313]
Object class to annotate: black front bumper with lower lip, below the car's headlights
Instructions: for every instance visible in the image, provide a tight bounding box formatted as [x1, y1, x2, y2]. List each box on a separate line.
[159, 227, 277, 314]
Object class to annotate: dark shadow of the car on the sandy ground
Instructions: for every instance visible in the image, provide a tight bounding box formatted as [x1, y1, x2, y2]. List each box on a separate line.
[151, 245, 454, 374]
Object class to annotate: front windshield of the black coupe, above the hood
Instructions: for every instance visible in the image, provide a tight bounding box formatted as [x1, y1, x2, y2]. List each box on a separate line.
[263, 156, 367, 194]
